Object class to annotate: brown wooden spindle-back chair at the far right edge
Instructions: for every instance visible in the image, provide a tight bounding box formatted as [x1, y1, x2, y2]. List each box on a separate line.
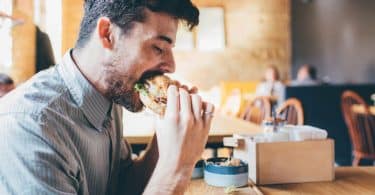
[341, 91, 375, 166]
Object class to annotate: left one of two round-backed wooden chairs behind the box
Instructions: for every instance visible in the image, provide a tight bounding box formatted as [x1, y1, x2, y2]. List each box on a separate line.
[240, 96, 271, 124]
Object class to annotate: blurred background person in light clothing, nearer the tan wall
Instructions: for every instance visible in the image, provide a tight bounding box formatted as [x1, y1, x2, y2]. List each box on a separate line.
[255, 65, 285, 105]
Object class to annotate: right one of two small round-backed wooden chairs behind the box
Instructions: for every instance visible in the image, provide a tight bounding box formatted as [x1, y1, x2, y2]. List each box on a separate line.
[276, 98, 303, 125]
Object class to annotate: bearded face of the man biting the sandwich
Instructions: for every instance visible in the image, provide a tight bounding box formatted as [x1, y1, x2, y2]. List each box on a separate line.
[105, 10, 178, 112]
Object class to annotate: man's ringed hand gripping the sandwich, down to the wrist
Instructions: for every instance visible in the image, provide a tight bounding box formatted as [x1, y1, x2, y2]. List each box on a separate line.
[156, 85, 214, 170]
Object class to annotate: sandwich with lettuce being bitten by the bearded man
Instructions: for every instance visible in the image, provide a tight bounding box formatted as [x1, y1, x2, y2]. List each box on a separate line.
[134, 75, 179, 116]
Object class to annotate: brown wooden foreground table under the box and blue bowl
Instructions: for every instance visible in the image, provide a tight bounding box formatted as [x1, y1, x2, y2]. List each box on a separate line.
[185, 167, 375, 195]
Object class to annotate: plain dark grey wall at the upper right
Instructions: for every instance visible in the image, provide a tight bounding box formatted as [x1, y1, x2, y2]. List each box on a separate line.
[292, 0, 375, 83]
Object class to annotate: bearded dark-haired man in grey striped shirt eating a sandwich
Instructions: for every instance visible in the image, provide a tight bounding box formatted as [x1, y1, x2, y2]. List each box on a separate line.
[0, 0, 214, 194]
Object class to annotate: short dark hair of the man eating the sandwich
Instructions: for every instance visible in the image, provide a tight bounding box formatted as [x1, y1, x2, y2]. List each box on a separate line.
[76, 0, 199, 48]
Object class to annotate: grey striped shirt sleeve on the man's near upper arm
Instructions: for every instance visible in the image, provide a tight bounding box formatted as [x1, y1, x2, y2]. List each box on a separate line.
[0, 114, 79, 195]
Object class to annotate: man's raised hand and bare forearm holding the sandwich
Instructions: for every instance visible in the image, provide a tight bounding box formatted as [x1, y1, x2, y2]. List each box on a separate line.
[145, 85, 214, 194]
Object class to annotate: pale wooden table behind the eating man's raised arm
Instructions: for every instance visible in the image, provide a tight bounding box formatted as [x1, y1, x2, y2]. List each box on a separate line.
[123, 110, 262, 144]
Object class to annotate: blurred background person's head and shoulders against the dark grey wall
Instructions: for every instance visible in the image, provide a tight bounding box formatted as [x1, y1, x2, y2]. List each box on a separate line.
[290, 64, 320, 86]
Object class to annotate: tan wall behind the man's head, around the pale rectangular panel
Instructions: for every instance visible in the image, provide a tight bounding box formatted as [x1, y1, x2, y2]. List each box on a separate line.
[62, 0, 291, 89]
